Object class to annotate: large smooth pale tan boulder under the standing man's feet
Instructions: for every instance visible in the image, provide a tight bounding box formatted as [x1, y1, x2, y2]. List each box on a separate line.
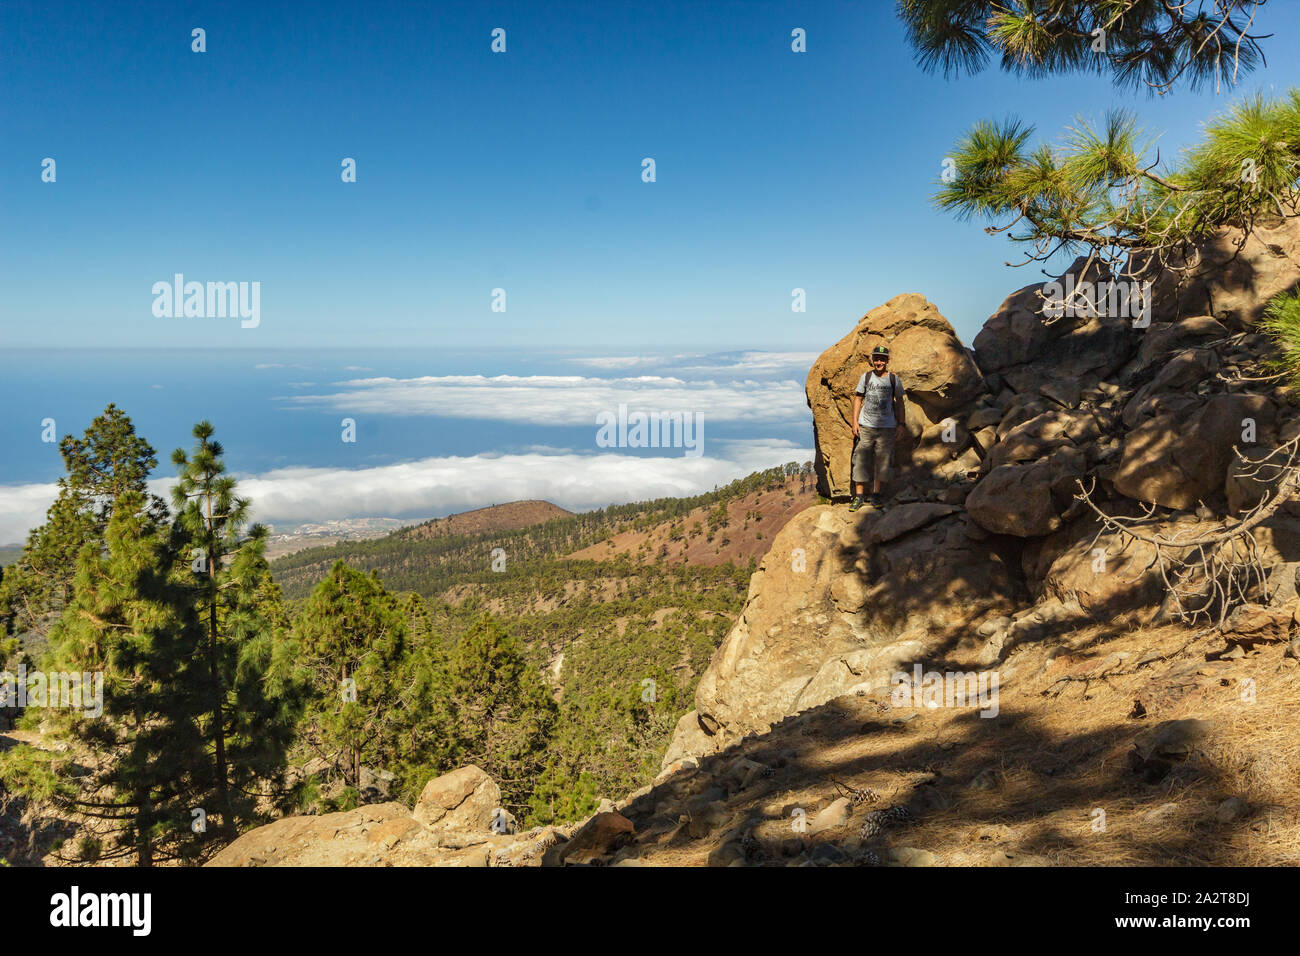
[668, 502, 1014, 761]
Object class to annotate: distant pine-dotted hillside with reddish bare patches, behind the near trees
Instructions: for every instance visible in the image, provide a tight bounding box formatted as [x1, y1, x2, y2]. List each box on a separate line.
[261, 463, 813, 822]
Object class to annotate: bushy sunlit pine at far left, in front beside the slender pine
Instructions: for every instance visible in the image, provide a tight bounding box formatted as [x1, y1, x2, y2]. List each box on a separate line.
[5, 490, 207, 866]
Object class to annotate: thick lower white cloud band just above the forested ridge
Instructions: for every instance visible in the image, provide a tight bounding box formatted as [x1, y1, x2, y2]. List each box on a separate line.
[0, 440, 813, 542]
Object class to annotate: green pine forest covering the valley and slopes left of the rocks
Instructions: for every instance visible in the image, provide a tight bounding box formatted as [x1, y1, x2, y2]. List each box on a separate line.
[0, 405, 807, 865]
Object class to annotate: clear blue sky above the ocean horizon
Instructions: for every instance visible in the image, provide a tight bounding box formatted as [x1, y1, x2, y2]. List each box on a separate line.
[0, 0, 1300, 350]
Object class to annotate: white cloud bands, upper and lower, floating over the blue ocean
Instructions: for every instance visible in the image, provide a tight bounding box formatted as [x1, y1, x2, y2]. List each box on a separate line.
[0, 351, 815, 542]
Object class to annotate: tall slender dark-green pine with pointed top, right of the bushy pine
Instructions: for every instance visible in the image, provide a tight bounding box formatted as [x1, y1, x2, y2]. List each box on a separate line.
[172, 421, 291, 839]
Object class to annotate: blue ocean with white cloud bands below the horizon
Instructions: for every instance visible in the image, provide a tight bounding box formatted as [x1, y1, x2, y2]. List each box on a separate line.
[0, 343, 815, 545]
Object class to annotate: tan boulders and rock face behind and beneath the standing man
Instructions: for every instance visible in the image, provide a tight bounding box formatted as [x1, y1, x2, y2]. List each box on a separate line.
[664, 243, 1300, 773]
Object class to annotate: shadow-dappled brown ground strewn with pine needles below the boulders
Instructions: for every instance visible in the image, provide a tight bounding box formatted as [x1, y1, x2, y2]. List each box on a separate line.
[615, 626, 1300, 866]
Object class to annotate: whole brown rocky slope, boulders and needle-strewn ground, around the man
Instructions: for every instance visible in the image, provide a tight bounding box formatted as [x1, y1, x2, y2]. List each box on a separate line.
[208, 222, 1300, 865]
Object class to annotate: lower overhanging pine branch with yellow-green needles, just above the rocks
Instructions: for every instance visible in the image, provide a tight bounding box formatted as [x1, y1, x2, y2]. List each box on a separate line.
[935, 90, 1300, 281]
